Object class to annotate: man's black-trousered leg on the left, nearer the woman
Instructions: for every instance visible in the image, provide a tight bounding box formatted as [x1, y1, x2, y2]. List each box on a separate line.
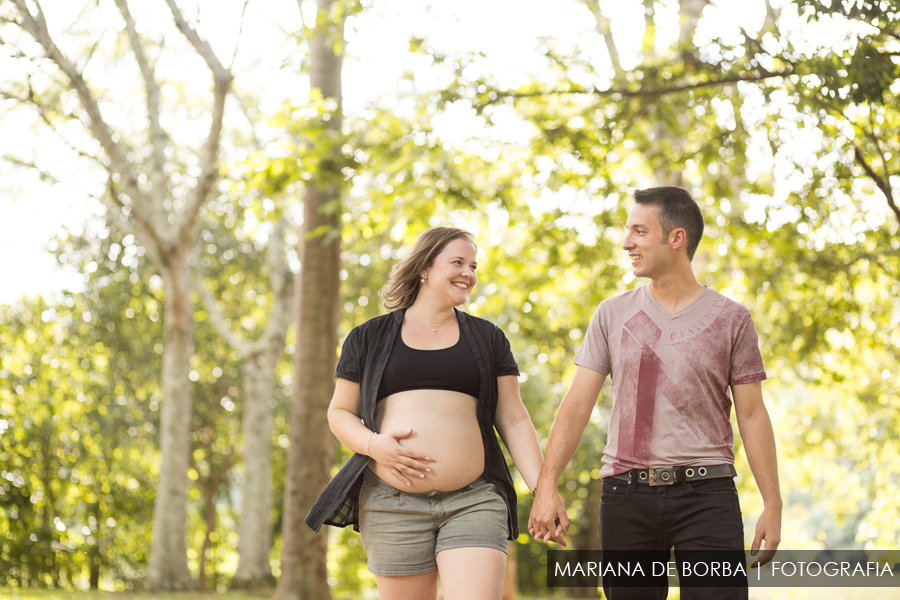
[600, 479, 669, 600]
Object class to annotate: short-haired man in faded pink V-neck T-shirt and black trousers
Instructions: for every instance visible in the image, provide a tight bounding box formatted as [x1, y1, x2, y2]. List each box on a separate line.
[528, 187, 782, 600]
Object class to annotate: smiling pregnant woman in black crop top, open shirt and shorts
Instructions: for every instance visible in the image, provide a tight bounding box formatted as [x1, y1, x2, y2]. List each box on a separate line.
[306, 227, 543, 600]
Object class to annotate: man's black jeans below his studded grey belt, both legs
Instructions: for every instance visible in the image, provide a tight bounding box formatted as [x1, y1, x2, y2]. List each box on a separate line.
[600, 477, 748, 600]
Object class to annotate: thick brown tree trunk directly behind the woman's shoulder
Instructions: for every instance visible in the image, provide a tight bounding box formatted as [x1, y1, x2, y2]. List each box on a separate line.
[275, 0, 344, 600]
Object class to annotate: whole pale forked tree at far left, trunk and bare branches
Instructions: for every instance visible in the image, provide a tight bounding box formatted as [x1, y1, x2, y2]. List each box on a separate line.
[12, 0, 232, 589]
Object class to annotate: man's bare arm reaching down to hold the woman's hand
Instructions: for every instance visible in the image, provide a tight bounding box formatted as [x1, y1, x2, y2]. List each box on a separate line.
[528, 367, 606, 546]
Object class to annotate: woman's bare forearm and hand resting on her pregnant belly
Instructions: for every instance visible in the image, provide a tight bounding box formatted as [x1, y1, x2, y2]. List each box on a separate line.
[328, 377, 436, 485]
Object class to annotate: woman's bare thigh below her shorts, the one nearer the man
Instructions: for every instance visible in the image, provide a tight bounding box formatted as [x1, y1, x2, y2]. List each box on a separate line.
[437, 547, 506, 600]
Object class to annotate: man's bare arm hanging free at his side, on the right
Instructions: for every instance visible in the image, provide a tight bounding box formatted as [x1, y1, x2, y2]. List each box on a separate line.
[731, 381, 782, 567]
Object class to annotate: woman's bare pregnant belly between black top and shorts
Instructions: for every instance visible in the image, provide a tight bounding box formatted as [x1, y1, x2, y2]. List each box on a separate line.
[369, 390, 484, 493]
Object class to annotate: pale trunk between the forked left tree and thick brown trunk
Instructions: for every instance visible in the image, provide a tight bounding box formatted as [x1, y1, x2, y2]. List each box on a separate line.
[232, 350, 284, 589]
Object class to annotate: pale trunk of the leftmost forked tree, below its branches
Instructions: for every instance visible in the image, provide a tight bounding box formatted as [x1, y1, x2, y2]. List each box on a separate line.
[147, 252, 194, 590]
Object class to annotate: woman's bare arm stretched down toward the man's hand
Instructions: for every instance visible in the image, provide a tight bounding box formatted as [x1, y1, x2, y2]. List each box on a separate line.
[494, 375, 544, 490]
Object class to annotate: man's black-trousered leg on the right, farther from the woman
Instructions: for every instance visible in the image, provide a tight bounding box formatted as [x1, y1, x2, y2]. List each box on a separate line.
[670, 477, 748, 600]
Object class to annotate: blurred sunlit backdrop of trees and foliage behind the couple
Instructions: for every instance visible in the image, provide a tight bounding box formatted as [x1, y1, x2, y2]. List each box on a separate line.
[0, 0, 900, 598]
